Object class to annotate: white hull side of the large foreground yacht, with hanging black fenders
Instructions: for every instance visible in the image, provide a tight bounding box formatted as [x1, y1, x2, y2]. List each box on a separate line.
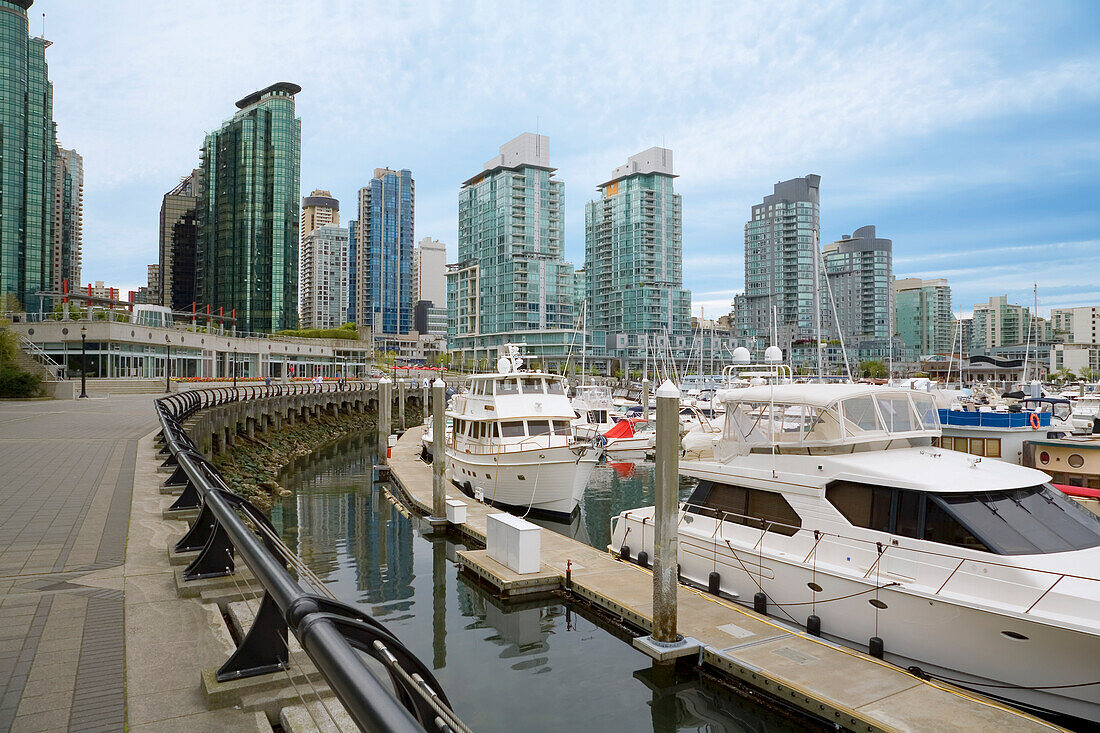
[611, 510, 1100, 721]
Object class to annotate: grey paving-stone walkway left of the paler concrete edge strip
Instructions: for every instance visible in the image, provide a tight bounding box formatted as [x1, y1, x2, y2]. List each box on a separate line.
[0, 395, 157, 732]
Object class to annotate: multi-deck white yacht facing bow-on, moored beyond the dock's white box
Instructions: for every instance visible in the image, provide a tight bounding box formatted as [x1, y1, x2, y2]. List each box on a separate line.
[446, 344, 598, 515]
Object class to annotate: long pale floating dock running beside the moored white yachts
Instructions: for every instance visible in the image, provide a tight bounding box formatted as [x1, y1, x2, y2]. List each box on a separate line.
[389, 427, 1064, 733]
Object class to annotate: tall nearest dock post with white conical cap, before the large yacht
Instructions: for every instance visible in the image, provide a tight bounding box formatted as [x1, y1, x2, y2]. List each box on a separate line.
[634, 380, 701, 665]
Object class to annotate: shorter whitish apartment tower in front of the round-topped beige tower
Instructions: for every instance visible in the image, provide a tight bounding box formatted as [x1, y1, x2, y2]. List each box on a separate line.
[300, 225, 349, 328]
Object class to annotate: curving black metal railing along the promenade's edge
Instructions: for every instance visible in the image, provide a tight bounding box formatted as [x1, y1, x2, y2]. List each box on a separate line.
[156, 383, 469, 733]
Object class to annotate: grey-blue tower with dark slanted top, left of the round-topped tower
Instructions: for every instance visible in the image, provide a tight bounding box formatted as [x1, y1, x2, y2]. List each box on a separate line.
[736, 175, 821, 350]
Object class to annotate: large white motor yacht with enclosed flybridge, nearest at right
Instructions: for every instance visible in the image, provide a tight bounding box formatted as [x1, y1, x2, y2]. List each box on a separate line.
[611, 384, 1100, 721]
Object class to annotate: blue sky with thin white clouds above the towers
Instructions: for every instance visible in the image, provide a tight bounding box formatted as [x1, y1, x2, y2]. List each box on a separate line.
[29, 0, 1100, 317]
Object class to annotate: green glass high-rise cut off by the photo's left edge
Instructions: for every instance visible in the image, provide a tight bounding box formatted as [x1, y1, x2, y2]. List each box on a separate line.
[0, 0, 57, 307]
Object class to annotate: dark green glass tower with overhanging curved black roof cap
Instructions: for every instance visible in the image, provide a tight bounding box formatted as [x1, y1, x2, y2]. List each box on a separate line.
[196, 81, 301, 331]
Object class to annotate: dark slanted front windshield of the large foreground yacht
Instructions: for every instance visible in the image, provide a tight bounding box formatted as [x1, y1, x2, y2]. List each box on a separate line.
[930, 485, 1100, 555]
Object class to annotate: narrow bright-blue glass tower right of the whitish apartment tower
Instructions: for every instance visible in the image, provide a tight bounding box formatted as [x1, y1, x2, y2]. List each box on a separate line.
[355, 168, 416, 333]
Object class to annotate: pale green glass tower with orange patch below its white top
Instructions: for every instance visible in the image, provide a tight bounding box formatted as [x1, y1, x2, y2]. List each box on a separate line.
[584, 147, 691, 349]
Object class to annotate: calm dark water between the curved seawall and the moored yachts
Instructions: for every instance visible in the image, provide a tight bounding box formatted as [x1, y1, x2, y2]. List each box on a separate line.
[272, 436, 805, 733]
